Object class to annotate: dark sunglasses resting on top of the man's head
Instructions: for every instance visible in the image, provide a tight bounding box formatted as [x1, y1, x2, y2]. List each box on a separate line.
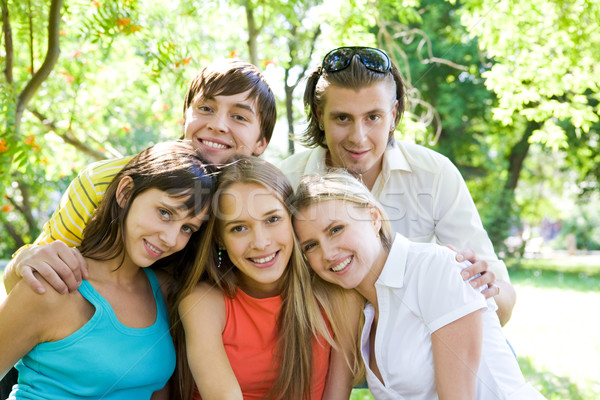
[322, 46, 392, 72]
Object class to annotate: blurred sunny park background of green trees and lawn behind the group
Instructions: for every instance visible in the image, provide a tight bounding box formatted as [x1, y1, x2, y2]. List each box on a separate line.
[0, 0, 600, 399]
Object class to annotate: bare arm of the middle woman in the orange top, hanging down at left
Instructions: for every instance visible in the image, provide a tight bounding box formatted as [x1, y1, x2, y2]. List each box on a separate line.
[179, 282, 243, 400]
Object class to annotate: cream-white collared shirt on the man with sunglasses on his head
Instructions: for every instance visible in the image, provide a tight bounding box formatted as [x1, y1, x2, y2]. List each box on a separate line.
[278, 141, 510, 282]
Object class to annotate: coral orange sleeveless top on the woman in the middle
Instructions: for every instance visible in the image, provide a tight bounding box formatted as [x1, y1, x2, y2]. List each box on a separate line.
[194, 289, 331, 400]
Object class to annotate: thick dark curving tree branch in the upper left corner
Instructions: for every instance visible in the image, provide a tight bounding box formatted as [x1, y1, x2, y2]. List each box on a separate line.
[15, 0, 63, 132]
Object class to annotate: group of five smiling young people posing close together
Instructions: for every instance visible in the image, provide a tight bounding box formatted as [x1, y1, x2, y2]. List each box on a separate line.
[0, 47, 543, 400]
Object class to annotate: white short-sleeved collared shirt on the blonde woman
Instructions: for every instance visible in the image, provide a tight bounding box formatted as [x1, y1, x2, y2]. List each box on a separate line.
[361, 235, 543, 400]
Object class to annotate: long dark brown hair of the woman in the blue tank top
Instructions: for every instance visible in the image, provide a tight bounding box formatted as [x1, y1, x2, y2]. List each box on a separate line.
[79, 141, 215, 279]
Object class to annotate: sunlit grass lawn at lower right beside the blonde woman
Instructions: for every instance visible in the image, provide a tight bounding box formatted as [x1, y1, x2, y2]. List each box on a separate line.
[0, 257, 600, 400]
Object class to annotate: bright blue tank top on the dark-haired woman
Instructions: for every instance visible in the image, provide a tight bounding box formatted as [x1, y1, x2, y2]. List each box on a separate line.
[9, 268, 175, 400]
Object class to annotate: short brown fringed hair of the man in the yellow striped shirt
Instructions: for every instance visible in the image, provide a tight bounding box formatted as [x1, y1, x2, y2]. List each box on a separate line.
[183, 61, 277, 143]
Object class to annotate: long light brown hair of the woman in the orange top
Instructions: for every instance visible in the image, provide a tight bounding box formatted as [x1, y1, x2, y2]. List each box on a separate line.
[174, 157, 333, 400]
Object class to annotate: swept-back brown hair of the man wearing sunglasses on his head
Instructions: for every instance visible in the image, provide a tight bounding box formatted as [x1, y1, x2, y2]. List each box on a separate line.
[300, 51, 406, 148]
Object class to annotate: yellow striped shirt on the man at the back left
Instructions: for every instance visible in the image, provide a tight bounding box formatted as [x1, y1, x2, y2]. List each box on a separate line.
[34, 156, 133, 247]
